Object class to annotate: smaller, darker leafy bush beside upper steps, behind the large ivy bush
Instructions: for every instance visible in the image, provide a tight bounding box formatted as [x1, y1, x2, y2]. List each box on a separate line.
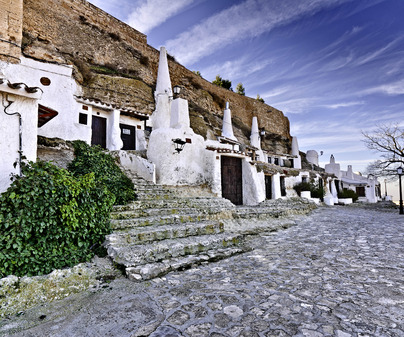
[68, 140, 136, 205]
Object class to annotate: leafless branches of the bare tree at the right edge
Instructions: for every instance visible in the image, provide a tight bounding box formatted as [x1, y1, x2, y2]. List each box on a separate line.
[362, 124, 404, 176]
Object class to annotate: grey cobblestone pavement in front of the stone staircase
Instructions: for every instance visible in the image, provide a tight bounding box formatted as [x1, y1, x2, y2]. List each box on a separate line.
[0, 206, 404, 337]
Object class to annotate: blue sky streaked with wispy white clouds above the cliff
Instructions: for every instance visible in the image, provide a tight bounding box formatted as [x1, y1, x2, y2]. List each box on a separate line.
[90, 0, 404, 176]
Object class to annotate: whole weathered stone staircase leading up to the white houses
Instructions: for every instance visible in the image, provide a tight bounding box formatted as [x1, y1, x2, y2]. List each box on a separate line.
[105, 174, 316, 281]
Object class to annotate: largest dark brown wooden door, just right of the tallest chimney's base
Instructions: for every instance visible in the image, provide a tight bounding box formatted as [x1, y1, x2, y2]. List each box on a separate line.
[221, 156, 243, 205]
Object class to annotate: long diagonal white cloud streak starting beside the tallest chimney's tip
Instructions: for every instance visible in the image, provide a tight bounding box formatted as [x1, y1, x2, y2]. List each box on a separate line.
[166, 0, 350, 64]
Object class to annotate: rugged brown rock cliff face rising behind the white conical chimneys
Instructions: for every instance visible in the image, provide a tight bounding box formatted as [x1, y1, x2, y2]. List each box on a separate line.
[22, 0, 291, 153]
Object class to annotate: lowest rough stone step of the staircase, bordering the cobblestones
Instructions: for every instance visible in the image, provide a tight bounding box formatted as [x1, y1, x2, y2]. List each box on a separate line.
[125, 247, 249, 282]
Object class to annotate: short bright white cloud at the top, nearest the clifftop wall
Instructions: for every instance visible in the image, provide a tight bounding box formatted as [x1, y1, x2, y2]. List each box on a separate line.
[127, 0, 194, 34]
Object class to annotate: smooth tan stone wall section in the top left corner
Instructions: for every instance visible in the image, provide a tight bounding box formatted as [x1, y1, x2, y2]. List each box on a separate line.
[0, 0, 22, 63]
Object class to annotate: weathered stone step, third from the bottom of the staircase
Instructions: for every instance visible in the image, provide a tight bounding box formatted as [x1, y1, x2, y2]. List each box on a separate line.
[104, 222, 224, 247]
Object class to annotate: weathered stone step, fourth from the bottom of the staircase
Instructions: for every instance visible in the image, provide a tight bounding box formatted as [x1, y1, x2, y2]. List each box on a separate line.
[111, 211, 232, 230]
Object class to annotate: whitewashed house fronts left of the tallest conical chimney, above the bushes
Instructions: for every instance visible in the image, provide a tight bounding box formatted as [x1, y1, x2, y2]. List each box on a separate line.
[0, 57, 148, 192]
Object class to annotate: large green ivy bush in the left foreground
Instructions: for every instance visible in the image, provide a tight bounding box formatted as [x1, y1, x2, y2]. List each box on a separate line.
[0, 161, 115, 277]
